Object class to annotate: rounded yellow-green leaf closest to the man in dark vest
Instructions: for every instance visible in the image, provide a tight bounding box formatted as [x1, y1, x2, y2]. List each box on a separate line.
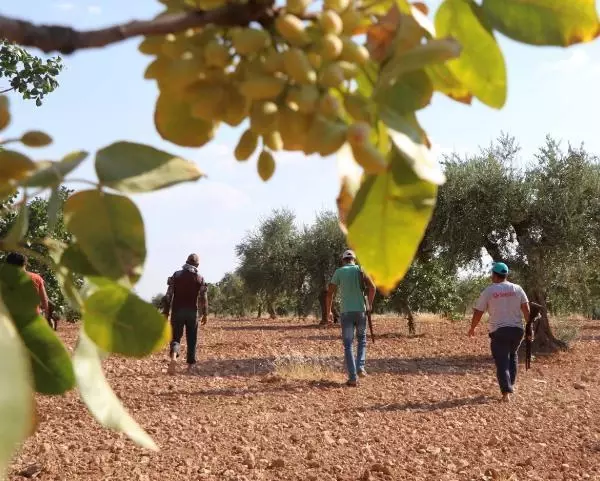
[83, 283, 171, 357]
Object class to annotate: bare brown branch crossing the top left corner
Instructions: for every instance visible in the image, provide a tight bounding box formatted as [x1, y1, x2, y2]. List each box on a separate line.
[0, 1, 276, 54]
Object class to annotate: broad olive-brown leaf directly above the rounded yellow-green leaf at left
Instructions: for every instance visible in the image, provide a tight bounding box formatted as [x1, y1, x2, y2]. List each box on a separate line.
[64, 190, 146, 281]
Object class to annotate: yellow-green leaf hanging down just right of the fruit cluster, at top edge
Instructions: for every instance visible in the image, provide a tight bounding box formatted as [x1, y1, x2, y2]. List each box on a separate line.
[435, 0, 506, 108]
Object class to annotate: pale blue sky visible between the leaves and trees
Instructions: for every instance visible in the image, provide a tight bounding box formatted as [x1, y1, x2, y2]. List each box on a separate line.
[0, 0, 600, 298]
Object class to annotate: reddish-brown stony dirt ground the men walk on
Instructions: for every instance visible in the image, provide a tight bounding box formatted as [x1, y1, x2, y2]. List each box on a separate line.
[10, 318, 600, 481]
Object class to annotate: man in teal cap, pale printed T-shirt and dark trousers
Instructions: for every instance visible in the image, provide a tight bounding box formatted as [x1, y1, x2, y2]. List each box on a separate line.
[469, 262, 529, 402]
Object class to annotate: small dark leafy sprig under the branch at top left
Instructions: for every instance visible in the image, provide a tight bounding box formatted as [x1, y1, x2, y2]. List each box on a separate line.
[0, 41, 63, 107]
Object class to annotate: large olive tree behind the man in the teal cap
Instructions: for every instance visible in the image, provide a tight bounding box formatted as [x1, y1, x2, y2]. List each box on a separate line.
[430, 136, 600, 351]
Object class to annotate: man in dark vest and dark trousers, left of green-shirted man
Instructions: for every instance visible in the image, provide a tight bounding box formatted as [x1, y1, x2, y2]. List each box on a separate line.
[163, 254, 208, 374]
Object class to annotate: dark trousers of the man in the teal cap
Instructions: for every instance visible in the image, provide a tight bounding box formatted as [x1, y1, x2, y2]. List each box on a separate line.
[490, 327, 525, 394]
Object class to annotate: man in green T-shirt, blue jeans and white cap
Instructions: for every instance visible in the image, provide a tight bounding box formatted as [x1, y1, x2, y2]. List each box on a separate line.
[327, 250, 375, 386]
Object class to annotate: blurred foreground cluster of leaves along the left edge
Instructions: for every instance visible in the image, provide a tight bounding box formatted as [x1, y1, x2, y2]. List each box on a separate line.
[0, 96, 201, 471]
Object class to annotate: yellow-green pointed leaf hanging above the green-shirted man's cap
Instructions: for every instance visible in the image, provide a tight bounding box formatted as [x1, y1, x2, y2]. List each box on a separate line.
[347, 146, 437, 295]
